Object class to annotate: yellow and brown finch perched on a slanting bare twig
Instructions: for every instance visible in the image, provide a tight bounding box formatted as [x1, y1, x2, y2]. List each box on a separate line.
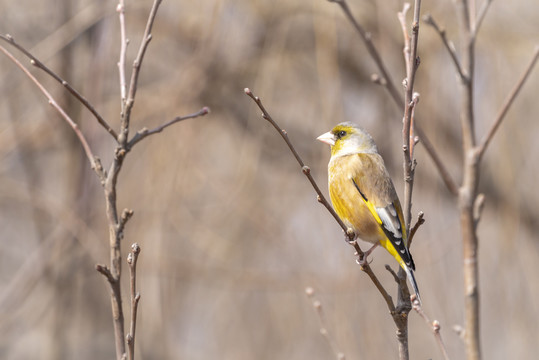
[317, 122, 421, 304]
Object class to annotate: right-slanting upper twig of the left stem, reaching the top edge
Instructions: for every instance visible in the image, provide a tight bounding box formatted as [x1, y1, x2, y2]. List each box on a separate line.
[119, 0, 162, 144]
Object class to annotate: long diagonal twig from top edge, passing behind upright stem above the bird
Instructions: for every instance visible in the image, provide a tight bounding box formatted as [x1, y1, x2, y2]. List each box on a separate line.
[328, 0, 458, 195]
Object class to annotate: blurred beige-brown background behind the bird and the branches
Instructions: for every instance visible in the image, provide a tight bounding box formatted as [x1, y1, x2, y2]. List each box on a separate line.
[0, 0, 539, 360]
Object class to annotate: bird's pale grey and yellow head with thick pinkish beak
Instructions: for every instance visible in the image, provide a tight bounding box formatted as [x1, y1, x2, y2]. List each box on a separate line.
[317, 122, 378, 157]
